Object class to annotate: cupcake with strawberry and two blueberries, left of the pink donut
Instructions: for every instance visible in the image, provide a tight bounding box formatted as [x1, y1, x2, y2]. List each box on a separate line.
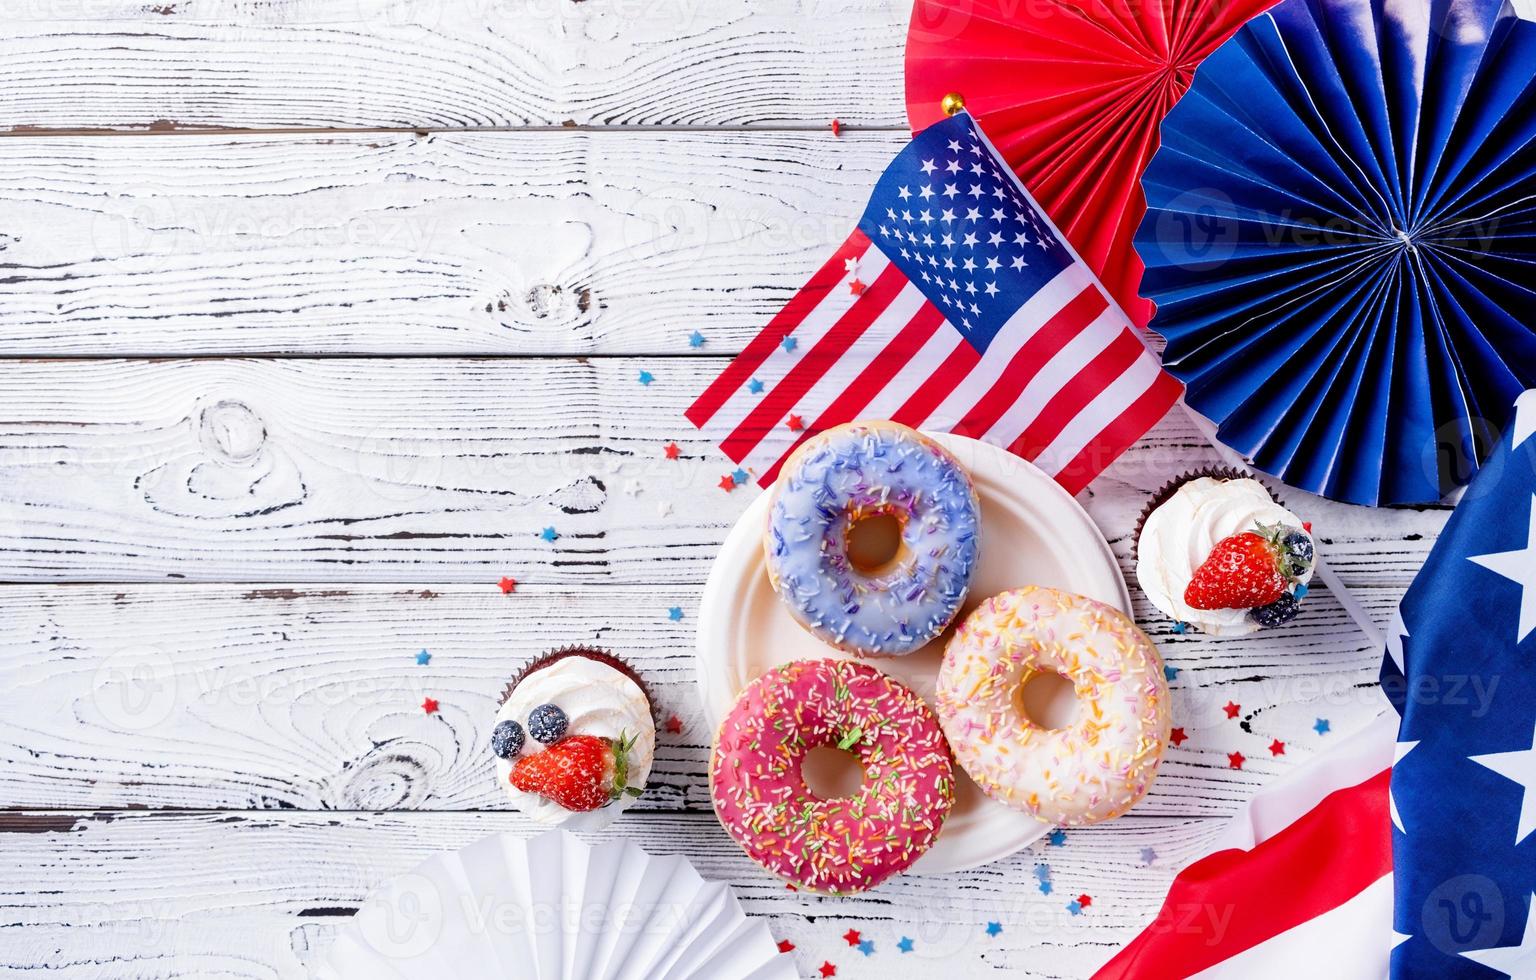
[492, 647, 656, 831]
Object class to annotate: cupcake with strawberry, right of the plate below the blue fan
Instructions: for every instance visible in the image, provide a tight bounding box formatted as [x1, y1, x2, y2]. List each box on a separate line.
[1135, 470, 1315, 636]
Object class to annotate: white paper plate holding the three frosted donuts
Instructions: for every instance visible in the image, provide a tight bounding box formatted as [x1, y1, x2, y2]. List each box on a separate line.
[697, 433, 1130, 874]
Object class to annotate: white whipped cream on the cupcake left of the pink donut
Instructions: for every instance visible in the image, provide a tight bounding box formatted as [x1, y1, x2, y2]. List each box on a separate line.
[493, 654, 656, 831]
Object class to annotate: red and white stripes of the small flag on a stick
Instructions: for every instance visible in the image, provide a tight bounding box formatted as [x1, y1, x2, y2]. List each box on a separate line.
[688, 230, 1181, 493]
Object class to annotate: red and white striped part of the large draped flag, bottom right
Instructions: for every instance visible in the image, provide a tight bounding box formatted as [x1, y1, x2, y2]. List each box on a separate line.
[1094, 711, 1398, 980]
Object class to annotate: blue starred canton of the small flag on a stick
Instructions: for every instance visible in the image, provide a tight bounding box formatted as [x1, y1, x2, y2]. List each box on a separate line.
[859, 112, 1072, 352]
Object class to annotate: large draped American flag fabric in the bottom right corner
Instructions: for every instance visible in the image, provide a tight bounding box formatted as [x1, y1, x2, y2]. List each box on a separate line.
[1095, 390, 1536, 980]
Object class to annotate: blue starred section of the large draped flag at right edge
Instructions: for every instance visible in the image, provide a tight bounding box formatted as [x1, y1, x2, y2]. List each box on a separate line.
[1382, 392, 1536, 980]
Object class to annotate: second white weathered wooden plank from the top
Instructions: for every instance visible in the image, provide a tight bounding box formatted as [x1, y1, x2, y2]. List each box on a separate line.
[0, 131, 903, 356]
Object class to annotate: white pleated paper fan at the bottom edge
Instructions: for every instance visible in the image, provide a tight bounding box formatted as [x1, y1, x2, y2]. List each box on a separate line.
[315, 831, 797, 980]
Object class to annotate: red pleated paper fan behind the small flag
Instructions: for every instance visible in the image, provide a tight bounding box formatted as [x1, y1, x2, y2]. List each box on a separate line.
[906, 0, 1275, 326]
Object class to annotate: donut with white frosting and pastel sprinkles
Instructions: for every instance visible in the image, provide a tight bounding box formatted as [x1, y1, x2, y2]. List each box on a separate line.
[935, 587, 1172, 825]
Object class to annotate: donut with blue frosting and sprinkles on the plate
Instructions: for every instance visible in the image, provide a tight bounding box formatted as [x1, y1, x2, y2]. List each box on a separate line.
[763, 422, 982, 656]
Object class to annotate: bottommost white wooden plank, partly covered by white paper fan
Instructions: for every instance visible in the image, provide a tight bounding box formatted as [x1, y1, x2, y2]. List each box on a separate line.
[0, 813, 1221, 980]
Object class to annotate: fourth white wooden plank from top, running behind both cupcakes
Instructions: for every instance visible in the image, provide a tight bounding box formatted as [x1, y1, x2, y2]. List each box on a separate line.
[0, 581, 1398, 816]
